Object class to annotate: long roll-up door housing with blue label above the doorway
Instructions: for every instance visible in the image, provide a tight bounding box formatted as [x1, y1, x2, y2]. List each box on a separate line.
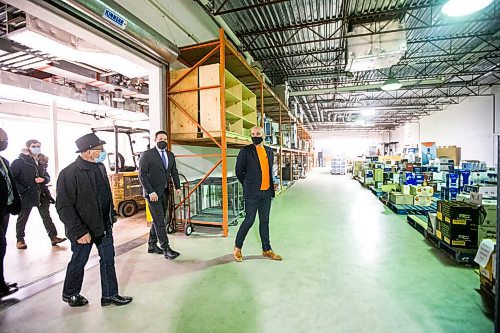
[67, 0, 179, 63]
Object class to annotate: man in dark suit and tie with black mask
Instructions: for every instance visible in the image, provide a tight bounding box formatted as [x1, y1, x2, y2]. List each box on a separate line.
[139, 131, 181, 259]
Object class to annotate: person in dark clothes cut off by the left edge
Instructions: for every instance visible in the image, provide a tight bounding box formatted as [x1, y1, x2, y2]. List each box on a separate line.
[0, 128, 21, 297]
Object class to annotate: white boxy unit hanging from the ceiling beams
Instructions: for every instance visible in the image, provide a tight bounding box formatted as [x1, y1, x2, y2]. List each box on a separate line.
[345, 20, 407, 72]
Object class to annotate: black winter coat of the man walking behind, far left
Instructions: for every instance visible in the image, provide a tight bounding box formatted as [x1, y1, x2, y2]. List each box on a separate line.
[10, 153, 50, 208]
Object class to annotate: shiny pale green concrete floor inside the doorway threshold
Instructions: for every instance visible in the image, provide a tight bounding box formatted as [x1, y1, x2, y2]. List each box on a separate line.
[0, 169, 493, 333]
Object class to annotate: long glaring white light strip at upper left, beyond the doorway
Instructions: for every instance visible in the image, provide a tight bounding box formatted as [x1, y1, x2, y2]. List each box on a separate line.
[7, 29, 148, 78]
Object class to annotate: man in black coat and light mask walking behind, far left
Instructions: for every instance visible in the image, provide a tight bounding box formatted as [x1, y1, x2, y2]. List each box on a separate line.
[11, 140, 66, 250]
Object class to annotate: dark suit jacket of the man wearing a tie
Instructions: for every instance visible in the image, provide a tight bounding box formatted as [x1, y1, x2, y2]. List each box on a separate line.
[139, 147, 181, 197]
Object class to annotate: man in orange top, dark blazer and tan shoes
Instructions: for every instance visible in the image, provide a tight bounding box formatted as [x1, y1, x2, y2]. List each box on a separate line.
[233, 127, 282, 262]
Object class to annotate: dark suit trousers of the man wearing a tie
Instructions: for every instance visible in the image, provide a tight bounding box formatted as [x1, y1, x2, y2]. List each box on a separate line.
[147, 191, 170, 250]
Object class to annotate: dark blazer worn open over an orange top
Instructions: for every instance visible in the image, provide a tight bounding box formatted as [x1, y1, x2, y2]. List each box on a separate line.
[236, 144, 274, 198]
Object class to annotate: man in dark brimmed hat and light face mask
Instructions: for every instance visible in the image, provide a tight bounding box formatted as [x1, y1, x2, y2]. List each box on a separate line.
[56, 133, 132, 307]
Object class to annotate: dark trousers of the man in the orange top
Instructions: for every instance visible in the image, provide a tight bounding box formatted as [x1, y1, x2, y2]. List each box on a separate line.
[235, 191, 271, 251]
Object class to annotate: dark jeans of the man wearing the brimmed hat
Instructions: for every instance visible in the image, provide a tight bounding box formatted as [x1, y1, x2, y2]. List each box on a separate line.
[63, 231, 118, 297]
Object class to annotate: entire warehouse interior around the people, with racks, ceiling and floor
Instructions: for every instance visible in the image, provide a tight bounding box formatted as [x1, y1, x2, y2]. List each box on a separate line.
[0, 0, 500, 332]
